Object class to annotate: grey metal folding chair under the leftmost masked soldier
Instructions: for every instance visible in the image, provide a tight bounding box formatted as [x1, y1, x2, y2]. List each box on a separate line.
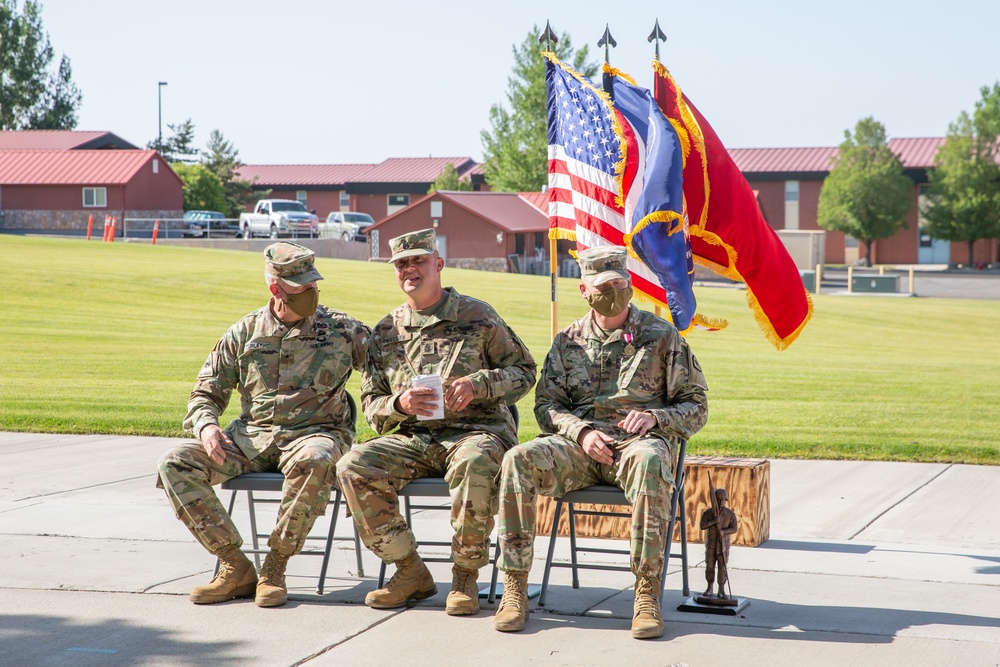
[215, 394, 365, 595]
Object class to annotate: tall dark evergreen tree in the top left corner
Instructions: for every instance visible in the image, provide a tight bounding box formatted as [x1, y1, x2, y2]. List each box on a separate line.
[0, 0, 82, 130]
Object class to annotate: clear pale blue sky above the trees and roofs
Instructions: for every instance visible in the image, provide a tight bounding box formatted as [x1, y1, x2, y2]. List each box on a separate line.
[42, 0, 1000, 164]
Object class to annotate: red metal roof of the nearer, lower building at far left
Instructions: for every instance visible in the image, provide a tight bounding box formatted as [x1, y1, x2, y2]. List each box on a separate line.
[0, 150, 169, 185]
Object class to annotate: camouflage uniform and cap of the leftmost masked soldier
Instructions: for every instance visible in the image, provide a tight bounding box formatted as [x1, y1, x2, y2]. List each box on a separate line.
[157, 244, 369, 555]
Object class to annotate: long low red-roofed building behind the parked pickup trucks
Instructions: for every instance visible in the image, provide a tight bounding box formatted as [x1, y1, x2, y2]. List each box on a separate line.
[238, 157, 485, 220]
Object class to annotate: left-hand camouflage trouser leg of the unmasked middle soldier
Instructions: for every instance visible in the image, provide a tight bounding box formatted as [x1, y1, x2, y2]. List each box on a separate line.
[337, 437, 443, 563]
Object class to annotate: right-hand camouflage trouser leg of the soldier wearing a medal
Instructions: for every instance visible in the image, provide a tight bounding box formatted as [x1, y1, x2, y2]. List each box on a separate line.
[617, 438, 674, 577]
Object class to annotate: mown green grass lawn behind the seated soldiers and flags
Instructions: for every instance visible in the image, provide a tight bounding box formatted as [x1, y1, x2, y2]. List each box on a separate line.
[0, 235, 1000, 464]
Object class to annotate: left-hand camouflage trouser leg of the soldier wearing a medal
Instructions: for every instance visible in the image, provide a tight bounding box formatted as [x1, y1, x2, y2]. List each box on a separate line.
[497, 436, 597, 572]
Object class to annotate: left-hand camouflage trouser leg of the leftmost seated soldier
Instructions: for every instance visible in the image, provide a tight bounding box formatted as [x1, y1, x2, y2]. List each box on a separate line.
[157, 442, 258, 555]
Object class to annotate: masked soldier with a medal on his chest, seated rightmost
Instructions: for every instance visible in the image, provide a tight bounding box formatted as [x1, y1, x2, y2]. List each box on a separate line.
[494, 246, 708, 639]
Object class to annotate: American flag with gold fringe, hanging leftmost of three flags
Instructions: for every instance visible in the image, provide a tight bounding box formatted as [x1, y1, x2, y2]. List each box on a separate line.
[545, 54, 667, 307]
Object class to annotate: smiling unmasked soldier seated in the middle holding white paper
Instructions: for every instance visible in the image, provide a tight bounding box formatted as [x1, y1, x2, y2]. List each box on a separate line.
[337, 229, 536, 615]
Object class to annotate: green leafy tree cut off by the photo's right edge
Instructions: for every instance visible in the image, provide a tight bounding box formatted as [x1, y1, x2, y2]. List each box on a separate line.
[923, 82, 1000, 266]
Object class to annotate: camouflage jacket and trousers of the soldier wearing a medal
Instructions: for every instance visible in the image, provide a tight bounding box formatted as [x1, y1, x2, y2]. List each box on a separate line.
[499, 305, 708, 577]
